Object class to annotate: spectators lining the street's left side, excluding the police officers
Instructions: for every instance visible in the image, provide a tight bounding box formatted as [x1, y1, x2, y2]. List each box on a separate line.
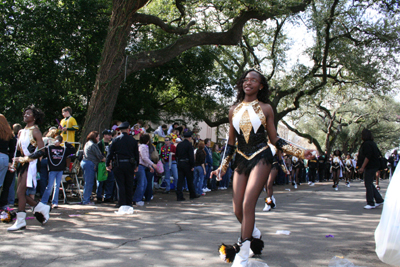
[0, 107, 232, 214]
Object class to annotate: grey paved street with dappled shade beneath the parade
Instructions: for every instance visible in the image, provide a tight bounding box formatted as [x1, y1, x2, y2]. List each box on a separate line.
[0, 180, 389, 267]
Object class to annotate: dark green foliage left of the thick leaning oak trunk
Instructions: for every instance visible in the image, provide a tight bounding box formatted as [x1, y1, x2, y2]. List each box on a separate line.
[0, 0, 110, 132]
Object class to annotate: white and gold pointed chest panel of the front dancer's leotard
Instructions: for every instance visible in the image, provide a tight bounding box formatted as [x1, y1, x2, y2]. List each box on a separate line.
[232, 99, 267, 143]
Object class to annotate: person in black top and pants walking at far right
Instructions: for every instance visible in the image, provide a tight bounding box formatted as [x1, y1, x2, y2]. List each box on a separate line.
[357, 129, 383, 209]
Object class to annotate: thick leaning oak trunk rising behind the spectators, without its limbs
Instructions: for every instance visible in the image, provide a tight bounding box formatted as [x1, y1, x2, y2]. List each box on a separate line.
[80, 0, 148, 142]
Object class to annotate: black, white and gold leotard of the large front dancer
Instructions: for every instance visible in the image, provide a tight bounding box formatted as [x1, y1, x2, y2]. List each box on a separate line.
[232, 100, 273, 175]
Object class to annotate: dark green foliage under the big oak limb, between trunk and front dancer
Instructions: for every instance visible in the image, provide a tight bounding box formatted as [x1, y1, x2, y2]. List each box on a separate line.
[113, 45, 232, 122]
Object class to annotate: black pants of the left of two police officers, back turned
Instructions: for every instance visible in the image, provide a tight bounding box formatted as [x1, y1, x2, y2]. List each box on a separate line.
[114, 162, 135, 206]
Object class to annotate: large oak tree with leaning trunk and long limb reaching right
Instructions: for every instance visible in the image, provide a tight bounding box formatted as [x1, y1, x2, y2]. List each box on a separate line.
[82, 0, 311, 141]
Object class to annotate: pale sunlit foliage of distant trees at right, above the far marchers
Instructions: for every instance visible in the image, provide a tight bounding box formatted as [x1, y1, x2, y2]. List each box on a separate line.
[289, 87, 400, 153]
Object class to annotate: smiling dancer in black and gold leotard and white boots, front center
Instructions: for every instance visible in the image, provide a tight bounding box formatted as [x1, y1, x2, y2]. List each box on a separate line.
[210, 70, 313, 266]
